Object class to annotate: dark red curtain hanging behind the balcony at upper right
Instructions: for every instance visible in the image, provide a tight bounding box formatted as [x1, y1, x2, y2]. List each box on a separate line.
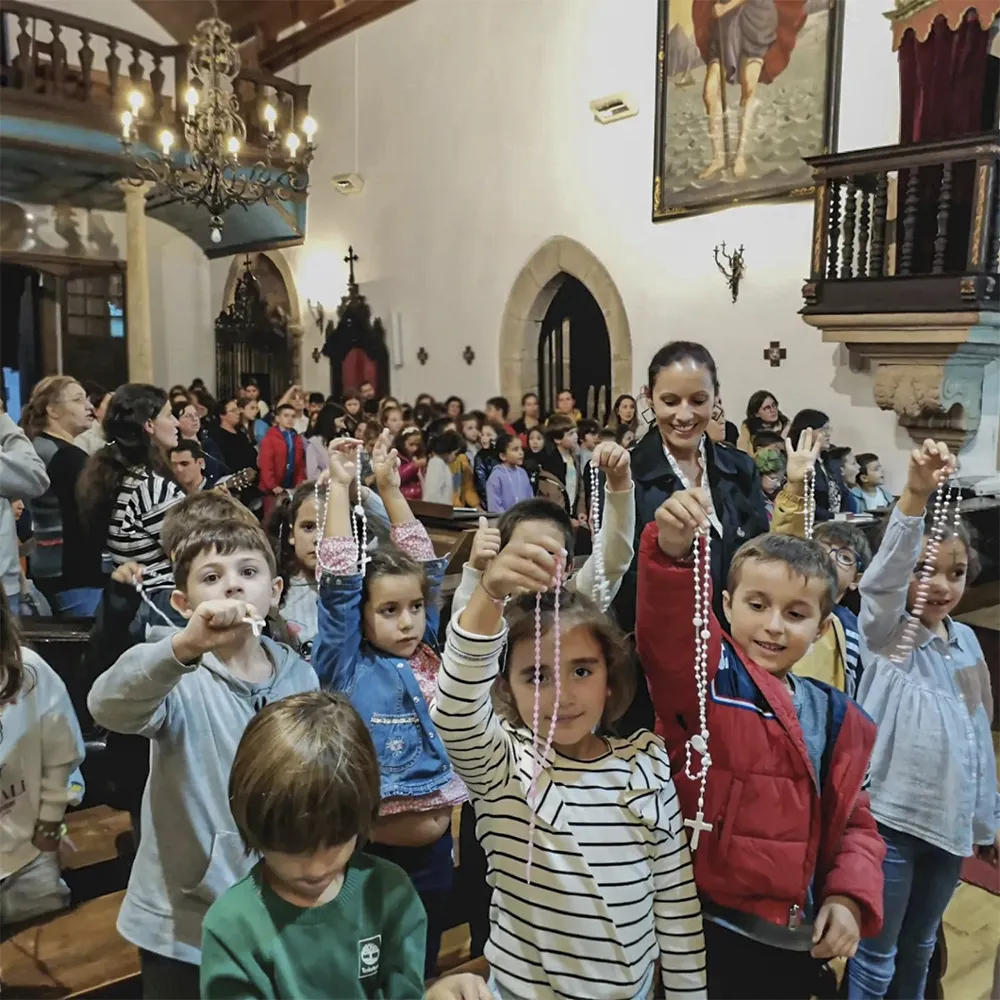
[899, 10, 990, 144]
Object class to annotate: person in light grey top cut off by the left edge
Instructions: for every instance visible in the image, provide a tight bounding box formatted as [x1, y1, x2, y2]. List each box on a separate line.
[0, 396, 49, 614]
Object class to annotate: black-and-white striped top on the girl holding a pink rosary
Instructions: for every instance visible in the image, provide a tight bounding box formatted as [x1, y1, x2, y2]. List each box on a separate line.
[431, 621, 705, 1000]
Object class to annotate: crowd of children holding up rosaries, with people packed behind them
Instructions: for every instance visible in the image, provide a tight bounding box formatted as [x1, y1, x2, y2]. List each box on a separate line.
[0, 354, 1000, 1000]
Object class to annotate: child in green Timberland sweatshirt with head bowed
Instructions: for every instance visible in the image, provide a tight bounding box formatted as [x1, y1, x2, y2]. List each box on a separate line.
[201, 691, 427, 1000]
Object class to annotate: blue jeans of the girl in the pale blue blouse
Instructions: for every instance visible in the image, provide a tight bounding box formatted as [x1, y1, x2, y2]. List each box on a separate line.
[847, 823, 964, 1000]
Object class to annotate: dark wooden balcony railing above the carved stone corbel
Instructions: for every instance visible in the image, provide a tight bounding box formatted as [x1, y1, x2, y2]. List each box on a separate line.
[802, 132, 1000, 315]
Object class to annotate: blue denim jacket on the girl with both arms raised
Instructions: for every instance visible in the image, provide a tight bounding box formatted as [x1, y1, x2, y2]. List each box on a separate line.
[312, 522, 453, 799]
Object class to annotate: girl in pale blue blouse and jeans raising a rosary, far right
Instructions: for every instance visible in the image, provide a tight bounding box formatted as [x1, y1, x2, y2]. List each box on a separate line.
[848, 441, 1000, 1000]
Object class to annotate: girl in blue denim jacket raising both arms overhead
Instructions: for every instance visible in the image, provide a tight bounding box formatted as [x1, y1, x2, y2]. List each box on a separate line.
[312, 433, 468, 976]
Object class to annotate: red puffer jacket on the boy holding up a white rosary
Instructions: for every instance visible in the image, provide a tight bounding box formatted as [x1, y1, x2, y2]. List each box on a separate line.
[636, 522, 885, 937]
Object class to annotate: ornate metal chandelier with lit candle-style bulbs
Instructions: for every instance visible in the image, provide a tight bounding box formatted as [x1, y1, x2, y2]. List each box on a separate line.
[121, 0, 316, 243]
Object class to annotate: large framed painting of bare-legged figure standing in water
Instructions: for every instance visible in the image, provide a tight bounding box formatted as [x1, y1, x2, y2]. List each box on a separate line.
[653, 0, 844, 222]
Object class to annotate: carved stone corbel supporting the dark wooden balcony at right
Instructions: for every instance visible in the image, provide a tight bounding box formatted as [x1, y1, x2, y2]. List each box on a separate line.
[802, 312, 1000, 451]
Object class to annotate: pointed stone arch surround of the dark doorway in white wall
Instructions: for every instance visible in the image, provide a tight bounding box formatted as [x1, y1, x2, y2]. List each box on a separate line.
[500, 236, 632, 410]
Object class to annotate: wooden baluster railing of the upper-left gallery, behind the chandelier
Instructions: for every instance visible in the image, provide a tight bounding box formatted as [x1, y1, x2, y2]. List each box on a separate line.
[0, 0, 309, 148]
